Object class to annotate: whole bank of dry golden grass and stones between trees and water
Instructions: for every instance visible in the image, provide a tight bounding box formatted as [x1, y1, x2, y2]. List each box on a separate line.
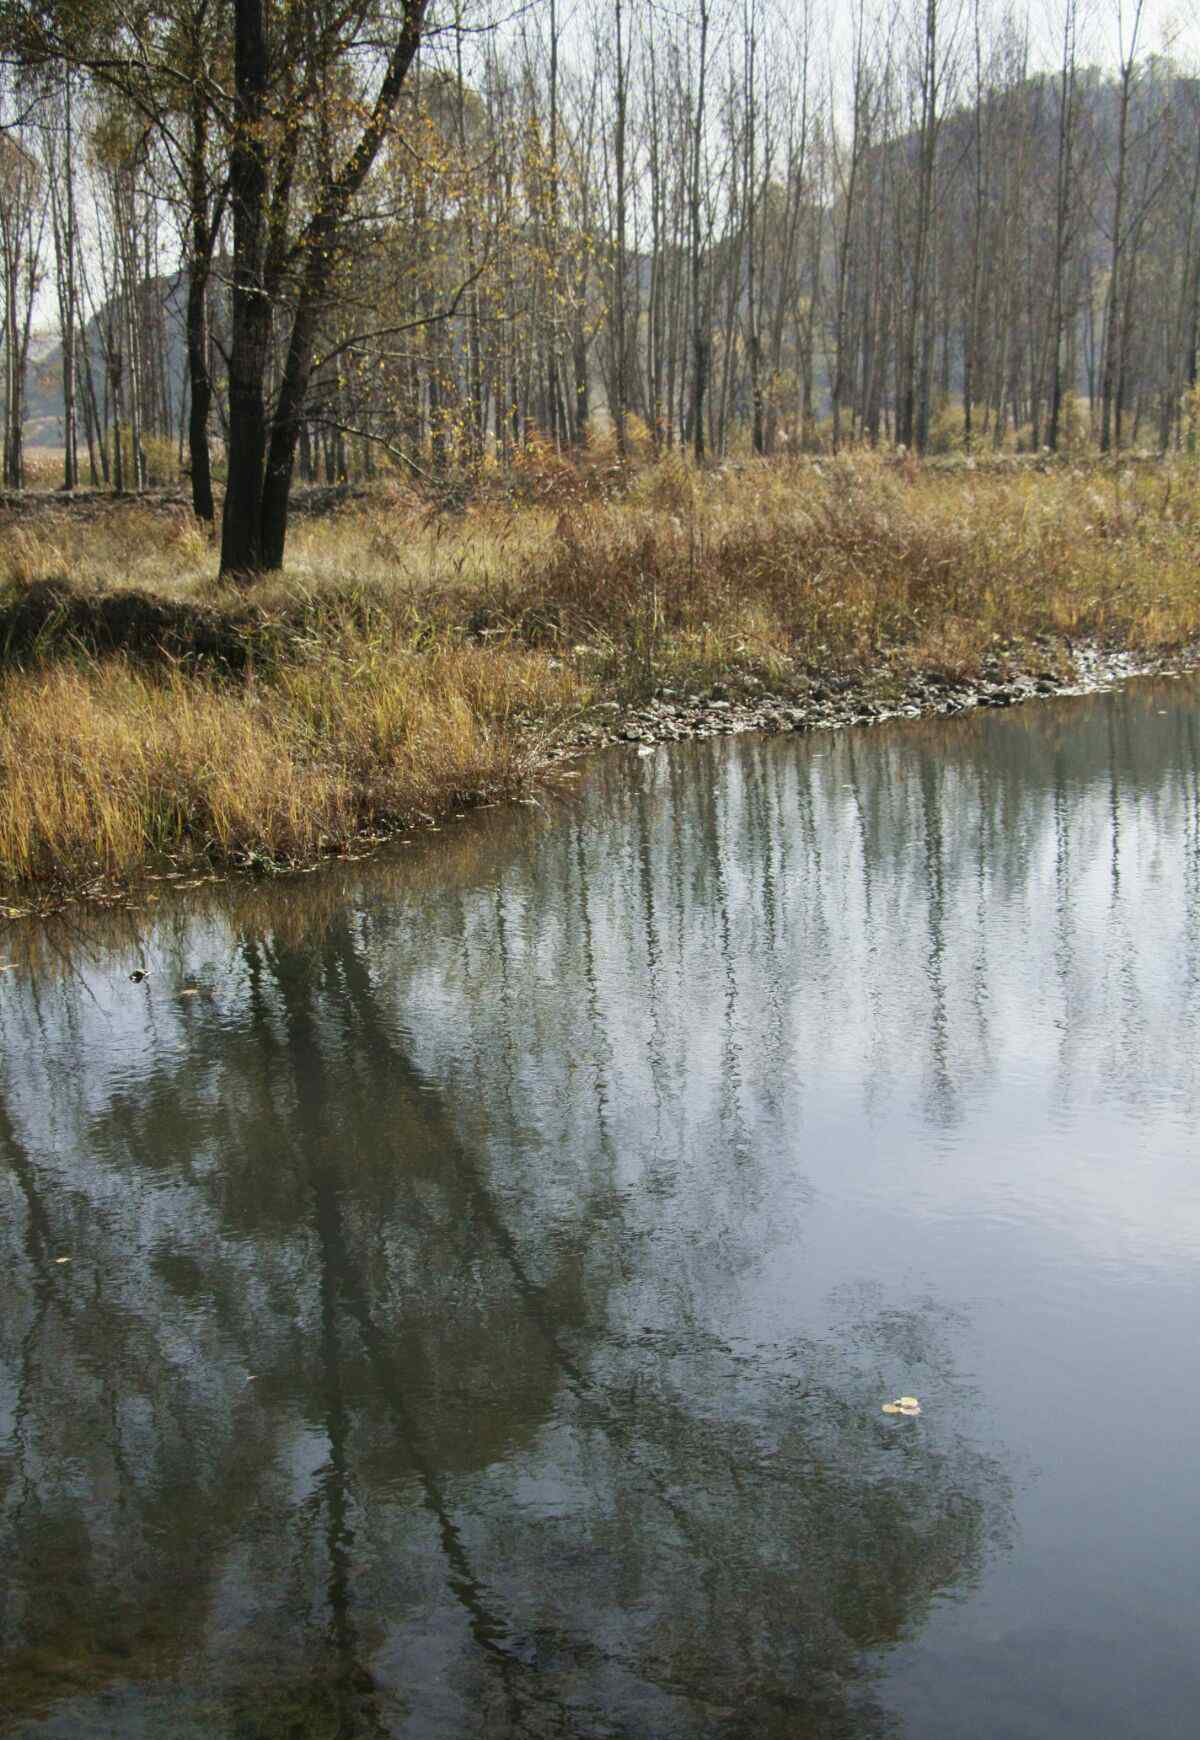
[0, 454, 1200, 915]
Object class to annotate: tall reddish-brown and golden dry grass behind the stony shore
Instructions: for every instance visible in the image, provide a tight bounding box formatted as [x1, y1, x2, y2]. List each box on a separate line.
[507, 458, 1200, 677]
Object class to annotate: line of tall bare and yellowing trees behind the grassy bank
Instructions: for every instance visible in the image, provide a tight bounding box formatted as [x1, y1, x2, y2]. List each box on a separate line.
[0, 0, 1200, 572]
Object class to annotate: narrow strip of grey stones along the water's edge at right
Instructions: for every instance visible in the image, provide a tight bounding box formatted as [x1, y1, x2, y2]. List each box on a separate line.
[550, 646, 1200, 764]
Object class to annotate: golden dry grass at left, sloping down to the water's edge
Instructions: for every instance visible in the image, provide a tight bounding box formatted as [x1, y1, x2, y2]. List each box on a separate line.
[0, 647, 576, 886]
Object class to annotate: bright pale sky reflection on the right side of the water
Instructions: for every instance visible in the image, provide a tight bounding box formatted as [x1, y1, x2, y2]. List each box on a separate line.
[354, 691, 1200, 1733]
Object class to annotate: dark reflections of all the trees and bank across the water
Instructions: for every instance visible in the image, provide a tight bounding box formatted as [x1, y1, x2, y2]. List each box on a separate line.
[0, 689, 1200, 1740]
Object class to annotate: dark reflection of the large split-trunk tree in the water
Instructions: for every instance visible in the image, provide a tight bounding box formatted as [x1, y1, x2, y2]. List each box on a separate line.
[3, 920, 1002, 1735]
